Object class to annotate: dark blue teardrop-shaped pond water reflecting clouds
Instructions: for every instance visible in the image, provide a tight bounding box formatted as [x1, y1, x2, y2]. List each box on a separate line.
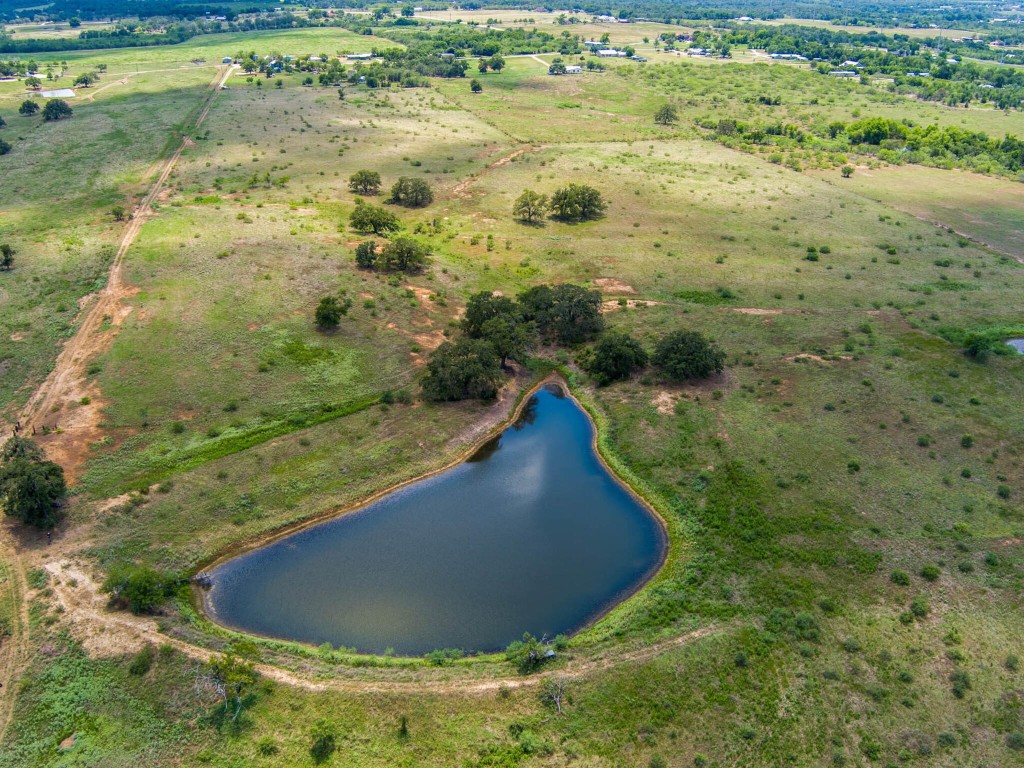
[207, 385, 666, 654]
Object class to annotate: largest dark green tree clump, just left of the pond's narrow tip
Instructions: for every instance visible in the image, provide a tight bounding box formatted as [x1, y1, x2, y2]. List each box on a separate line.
[422, 284, 604, 400]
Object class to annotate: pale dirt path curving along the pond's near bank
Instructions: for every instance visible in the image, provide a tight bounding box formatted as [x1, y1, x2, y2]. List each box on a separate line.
[44, 560, 721, 694]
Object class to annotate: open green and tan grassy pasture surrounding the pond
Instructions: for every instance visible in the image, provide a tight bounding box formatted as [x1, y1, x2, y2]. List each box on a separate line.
[0, 22, 1024, 768]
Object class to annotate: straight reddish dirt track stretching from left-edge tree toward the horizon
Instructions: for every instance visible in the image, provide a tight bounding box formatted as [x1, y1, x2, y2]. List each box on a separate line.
[19, 67, 232, 480]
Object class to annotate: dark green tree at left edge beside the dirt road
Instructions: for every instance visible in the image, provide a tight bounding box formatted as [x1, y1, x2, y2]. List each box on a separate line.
[0, 435, 68, 528]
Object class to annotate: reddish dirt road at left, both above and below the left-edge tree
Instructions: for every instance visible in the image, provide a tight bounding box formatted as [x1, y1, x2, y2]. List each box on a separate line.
[0, 65, 234, 740]
